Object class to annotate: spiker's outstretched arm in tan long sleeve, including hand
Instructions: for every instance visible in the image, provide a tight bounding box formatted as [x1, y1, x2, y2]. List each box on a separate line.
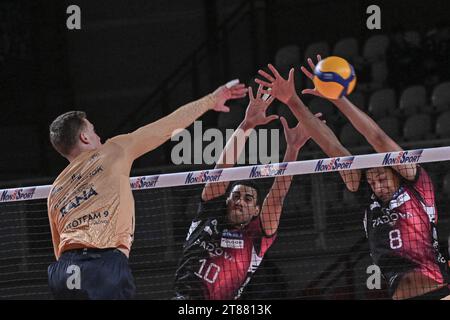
[113, 84, 247, 160]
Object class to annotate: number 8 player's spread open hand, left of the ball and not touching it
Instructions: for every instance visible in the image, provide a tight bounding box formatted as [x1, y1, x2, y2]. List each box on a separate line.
[255, 64, 297, 104]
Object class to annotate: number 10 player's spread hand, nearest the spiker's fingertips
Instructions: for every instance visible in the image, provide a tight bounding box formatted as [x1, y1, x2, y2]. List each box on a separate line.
[244, 85, 278, 128]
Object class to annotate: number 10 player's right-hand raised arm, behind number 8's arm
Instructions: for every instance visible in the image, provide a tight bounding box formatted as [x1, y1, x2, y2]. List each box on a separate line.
[261, 114, 321, 236]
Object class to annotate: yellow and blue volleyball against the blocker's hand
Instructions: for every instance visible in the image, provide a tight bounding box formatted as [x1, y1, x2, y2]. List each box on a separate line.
[313, 56, 356, 99]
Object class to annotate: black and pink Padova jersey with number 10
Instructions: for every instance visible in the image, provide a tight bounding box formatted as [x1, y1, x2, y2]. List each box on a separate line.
[175, 196, 276, 300]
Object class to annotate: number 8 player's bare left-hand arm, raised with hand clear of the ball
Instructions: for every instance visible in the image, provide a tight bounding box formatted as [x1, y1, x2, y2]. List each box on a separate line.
[255, 64, 361, 192]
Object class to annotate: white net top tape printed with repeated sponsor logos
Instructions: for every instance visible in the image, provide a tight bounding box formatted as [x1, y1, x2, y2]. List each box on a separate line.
[0, 146, 450, 202]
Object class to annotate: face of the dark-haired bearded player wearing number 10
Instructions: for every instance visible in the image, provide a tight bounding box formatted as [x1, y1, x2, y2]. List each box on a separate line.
[227, 185, 259, 224]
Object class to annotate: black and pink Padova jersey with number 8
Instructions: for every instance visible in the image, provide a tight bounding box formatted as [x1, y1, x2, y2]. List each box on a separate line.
[364, 166, 448, 295]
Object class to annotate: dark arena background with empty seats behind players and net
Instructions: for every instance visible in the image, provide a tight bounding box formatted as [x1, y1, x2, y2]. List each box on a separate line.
[0, 0, 450, 299]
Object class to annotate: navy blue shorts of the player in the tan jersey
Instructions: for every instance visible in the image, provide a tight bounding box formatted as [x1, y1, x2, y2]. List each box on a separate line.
[48, 249, 136, 300]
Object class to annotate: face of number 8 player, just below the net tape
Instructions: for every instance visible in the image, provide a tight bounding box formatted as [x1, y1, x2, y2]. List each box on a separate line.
[367, 168, 398, 202]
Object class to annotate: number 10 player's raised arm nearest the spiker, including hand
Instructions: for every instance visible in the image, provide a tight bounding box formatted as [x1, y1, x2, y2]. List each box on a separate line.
[202, 86, 278, 201]
